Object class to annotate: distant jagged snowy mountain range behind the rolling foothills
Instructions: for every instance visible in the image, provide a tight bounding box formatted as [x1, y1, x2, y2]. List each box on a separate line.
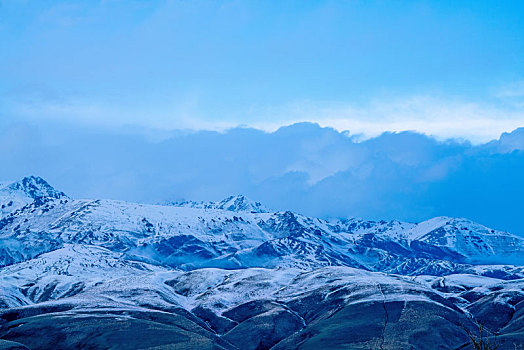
[0, 175, 524, 278]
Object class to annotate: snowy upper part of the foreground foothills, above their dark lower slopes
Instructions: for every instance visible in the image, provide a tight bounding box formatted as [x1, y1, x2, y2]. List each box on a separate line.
[0, 250, 474, 315]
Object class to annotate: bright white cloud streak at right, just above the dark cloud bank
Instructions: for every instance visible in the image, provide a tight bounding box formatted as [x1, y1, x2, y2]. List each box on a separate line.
[248, 96, 524, 143]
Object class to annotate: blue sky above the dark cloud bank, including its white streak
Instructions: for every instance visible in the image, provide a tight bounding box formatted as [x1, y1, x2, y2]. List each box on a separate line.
[0, 0, 524, 143]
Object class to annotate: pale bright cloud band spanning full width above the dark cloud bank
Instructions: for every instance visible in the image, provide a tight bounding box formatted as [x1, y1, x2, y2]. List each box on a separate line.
[0, 91, 524, 144]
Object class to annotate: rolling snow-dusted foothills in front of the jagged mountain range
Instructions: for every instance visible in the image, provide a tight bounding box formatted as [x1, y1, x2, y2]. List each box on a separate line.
[5, 250, 524, 349]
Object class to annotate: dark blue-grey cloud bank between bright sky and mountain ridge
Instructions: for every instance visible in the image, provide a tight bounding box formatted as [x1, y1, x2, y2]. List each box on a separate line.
[0, 123, 524, 235]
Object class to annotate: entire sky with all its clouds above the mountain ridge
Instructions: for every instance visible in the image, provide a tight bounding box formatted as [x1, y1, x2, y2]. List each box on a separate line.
[0, 0, 524, 235]
